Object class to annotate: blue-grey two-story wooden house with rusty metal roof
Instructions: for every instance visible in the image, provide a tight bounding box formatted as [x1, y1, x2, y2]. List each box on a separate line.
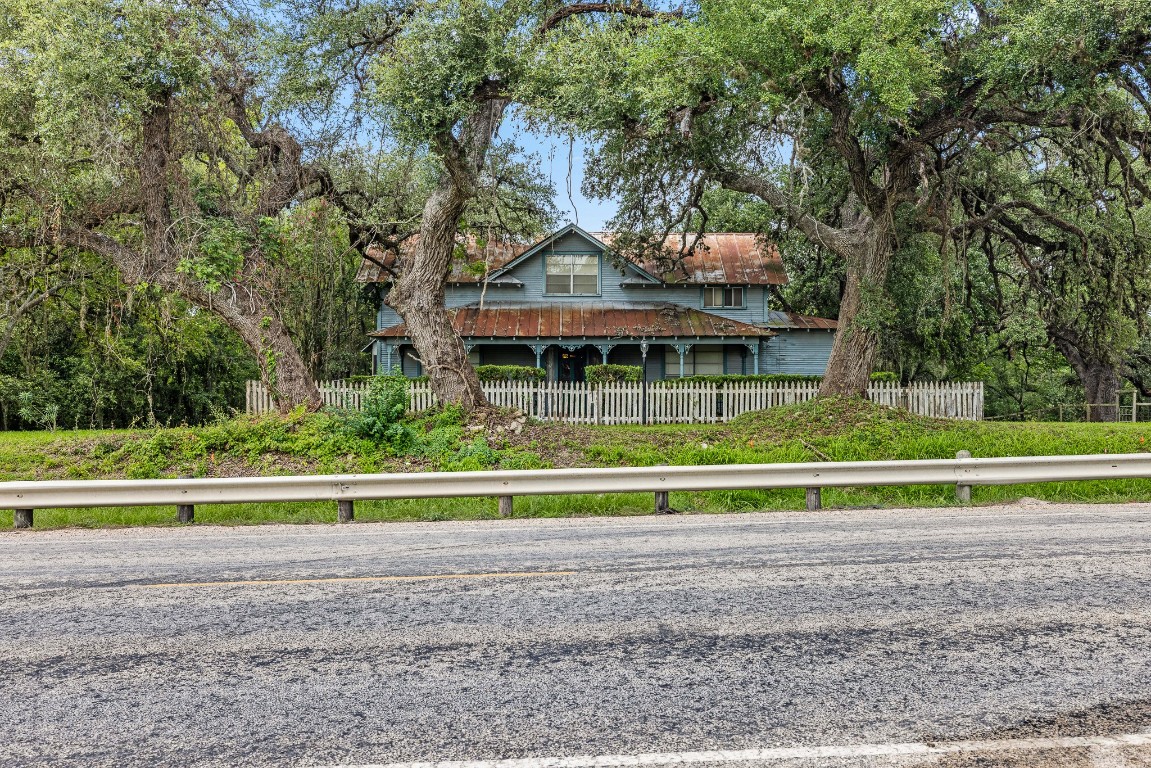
[359, 225, 836, 381]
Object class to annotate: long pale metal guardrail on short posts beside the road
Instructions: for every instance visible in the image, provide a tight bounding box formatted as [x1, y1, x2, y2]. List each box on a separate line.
[0, 454, 1151, 527]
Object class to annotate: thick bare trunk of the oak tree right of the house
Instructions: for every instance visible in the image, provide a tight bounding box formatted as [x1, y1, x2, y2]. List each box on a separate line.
[820, 216, 894, 397]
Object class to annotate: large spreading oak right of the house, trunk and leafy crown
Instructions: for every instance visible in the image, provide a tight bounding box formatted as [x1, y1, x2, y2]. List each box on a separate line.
[534, 0, 1151, 394]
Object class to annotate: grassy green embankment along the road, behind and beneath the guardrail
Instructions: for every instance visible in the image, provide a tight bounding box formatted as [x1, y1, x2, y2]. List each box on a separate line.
[0, 401, 1151, 529]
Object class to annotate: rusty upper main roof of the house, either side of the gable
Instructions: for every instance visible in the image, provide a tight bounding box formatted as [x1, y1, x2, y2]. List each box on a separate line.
[356, 230, 787, 286]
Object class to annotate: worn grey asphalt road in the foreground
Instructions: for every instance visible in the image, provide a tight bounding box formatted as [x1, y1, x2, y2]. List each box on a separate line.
[0, 504, 1151, 768]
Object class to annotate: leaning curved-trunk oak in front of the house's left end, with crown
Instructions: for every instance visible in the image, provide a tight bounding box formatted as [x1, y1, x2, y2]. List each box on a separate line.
[272, 0, 552, 410]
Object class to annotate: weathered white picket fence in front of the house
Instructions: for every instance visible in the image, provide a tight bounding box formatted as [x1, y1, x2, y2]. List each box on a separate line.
[245, 380, 983, 424]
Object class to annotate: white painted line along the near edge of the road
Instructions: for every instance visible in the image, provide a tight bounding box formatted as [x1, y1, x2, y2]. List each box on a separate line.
[318, 733, 1151, 768]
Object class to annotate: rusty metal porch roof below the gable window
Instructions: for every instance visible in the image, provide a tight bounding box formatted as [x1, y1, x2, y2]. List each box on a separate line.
[371, 303, 773, 339]
